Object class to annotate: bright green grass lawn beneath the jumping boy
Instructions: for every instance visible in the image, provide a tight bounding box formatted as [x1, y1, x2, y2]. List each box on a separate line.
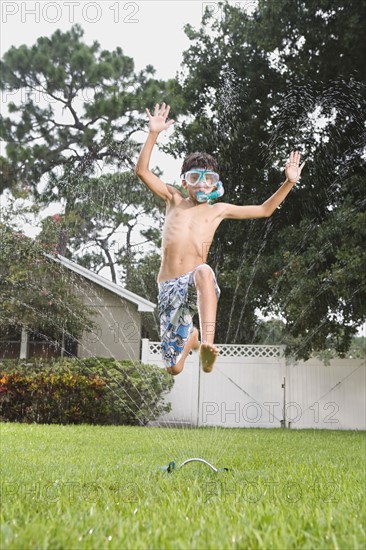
[0, 424, 366, 550]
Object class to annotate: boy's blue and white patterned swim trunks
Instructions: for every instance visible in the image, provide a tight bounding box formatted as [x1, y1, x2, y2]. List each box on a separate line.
[158, 264, 221, 367]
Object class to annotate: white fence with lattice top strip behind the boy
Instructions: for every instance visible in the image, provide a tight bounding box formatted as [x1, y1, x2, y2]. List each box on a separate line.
[141, 339, 366, 430]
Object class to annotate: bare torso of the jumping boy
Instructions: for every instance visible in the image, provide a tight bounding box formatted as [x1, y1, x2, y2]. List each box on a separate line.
[158, 193, 222, 282]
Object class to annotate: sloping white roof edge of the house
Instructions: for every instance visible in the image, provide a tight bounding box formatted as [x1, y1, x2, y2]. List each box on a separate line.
[46, 254, 156, 312]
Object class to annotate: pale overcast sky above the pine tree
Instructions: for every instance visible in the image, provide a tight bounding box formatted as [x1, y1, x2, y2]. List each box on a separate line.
[0, 0, 217, 182]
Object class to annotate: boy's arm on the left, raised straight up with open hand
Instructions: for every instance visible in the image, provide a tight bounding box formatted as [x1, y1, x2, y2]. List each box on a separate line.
[135, 103, 175, 201]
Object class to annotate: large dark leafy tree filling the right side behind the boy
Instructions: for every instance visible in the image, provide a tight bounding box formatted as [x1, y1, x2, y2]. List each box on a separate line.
[166, 0, 366, 359]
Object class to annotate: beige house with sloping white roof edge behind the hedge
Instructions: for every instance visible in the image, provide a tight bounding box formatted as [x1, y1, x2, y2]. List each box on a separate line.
[0, 255, 156, 366]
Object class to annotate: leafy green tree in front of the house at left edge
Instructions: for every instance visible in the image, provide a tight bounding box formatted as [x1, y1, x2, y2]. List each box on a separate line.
[0, 219, 95, 339]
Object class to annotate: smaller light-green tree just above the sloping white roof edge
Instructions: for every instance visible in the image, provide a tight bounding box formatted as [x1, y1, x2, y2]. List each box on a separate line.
[39, 171, 162, 287]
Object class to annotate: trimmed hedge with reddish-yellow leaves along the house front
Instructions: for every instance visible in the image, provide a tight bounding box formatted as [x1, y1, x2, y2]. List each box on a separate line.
[0, 357, 174, 425]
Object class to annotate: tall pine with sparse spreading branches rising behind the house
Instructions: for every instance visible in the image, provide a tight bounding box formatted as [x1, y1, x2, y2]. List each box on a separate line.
[0, 25, 181, 280]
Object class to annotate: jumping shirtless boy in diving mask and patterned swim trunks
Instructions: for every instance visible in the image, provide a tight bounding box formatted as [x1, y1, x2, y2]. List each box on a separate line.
[135, 103, 305, 375]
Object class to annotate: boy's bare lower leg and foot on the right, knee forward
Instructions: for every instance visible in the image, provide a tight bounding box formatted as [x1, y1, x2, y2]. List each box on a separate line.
[194, 265, 219, 372]
